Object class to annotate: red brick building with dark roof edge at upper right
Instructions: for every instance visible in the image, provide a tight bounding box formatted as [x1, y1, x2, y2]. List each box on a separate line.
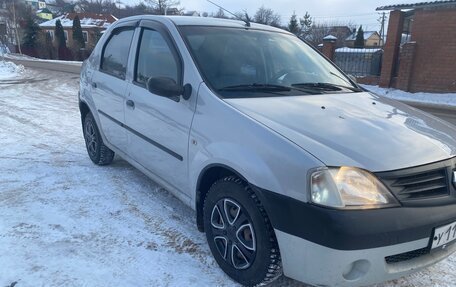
[377, 0, 456, 92]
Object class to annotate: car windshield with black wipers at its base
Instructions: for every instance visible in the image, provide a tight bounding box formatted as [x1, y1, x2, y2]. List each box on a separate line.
[180, 26, 359, 98]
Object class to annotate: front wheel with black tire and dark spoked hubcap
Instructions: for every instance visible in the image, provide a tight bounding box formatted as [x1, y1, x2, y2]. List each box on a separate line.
[204, 176, 282, 286]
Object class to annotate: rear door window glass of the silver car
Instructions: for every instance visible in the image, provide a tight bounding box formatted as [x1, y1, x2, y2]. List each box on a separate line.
[101, 29, 134, 79]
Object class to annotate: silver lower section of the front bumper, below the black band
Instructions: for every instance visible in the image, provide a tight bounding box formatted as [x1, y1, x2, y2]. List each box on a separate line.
[275, 230, 456, 287]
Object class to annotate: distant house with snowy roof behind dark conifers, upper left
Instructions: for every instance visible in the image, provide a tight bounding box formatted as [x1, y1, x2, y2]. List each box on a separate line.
[40, 13, 117, 49]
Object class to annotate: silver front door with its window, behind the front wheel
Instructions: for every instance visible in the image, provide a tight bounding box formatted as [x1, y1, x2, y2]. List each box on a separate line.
[125, 21, 194, 195]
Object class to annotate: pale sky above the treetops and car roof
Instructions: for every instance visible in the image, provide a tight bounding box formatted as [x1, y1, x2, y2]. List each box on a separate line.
[136, 0, 425, 31]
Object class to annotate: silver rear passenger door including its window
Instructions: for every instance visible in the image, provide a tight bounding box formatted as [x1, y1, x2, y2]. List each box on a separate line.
[92, 23, 135, 151]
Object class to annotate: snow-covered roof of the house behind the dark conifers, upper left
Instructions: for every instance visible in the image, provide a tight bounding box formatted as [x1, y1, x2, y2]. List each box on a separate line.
[40, 13, 117, 28]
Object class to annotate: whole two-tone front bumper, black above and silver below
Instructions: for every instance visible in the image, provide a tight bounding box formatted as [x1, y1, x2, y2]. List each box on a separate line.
[256, 188, 456, 286]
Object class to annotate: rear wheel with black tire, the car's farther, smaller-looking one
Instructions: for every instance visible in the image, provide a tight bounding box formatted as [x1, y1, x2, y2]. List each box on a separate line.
[82, 113, 114, 165]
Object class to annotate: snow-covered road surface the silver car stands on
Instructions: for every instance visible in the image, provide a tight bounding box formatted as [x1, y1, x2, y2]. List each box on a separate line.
[0, 70, 456, 287]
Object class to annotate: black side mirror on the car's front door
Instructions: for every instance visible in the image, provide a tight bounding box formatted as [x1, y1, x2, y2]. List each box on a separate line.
[147, 77, 192, 102]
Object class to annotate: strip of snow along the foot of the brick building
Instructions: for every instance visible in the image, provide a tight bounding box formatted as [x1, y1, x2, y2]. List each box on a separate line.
[361, 85, 456, 107]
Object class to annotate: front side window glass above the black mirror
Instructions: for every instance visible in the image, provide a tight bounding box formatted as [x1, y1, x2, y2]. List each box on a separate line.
[135, 29, 178, 85]
